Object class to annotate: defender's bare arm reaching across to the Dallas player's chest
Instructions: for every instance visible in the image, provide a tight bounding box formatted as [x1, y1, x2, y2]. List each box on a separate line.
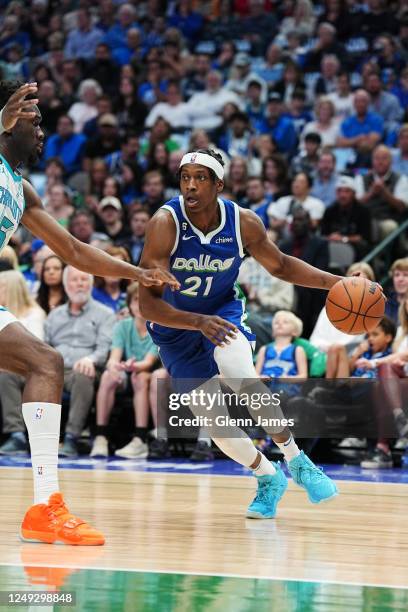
[22, 181, 179, 289]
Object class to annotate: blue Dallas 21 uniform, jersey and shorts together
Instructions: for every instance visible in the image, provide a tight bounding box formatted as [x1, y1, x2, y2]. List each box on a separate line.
[147, 196, 255, 379]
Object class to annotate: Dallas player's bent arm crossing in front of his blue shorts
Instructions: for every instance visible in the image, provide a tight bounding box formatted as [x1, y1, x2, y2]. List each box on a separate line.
[139, 210, 237, 346]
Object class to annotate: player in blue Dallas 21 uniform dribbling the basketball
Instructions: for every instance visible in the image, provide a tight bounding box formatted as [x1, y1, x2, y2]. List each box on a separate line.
[140, 150, 340, 518]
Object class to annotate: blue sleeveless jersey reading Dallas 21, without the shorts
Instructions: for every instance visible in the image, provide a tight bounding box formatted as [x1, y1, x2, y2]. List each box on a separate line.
[162, 196, 244, 315]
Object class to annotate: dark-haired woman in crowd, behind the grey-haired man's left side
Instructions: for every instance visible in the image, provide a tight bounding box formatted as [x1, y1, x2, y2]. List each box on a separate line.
[37, 255, 67, 315]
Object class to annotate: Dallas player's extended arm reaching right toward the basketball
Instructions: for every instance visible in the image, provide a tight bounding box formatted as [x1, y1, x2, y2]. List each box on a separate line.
[240, 210, 342, 290]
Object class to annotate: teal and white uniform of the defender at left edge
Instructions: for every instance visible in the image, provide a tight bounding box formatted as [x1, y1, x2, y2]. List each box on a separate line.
[0, 155, 25, 332]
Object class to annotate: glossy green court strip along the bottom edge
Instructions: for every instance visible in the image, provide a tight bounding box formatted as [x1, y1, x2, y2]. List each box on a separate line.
[0, 566, 408, 612]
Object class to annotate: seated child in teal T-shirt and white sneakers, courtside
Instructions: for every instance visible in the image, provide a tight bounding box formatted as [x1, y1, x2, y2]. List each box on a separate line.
[91, 283, 167, 459]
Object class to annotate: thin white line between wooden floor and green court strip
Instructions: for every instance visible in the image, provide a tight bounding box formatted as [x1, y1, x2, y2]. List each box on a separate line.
[0, 561, 408, 590]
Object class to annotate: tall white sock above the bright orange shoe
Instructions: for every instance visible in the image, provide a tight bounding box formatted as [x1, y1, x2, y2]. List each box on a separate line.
[23, 402, 61, 504]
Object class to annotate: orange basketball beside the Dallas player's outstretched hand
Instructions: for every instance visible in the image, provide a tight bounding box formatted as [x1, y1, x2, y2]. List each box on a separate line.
[326, 276, 385, 334]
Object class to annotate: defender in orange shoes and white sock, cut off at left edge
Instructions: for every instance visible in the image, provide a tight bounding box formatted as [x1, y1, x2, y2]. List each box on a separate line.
[0, 82, 179, 546]
